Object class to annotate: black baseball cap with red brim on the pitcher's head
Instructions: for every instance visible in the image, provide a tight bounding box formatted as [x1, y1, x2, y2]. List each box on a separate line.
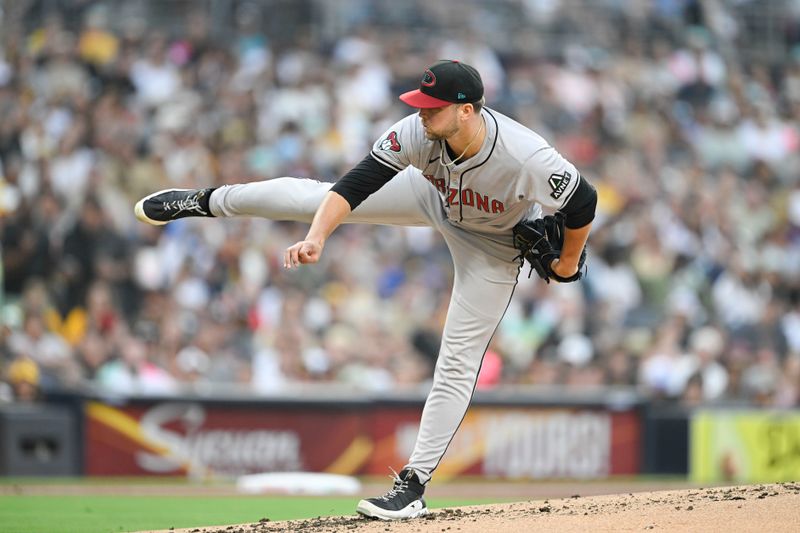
[400, 59, 483, 109]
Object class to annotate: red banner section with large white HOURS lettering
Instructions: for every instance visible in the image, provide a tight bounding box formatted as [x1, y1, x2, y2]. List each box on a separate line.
[367, 407, 641, 480]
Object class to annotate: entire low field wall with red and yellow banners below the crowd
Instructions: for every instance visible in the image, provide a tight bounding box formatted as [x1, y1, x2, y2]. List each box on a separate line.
[0, 389, 800, 483]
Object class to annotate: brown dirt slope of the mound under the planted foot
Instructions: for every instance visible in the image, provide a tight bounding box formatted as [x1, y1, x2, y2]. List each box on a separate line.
[144, 482, 800, 533]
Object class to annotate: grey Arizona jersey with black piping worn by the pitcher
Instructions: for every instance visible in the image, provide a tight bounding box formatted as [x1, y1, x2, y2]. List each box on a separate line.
[372, 108, 580, 233]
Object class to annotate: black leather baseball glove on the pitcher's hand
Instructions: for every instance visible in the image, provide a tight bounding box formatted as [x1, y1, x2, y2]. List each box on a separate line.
[512, 211, 586, 283]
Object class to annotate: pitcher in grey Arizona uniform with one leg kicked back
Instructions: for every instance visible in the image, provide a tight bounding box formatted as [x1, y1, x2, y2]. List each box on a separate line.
[134, 60, 597, 520]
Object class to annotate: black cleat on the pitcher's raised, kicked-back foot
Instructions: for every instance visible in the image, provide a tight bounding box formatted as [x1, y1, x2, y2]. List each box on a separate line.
[133, 188, 214, 226]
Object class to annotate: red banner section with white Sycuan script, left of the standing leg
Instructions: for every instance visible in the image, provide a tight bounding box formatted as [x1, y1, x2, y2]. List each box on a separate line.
[85, 402, 365, 477]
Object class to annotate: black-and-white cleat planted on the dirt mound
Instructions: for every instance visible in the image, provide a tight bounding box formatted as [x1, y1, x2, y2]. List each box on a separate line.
[356, 469, 428, 520]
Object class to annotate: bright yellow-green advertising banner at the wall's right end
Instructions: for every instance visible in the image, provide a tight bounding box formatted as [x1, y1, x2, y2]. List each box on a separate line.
[690, 410, 800, 483]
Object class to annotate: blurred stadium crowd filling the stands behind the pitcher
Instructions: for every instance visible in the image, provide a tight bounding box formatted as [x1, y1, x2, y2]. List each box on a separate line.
[0, 1, 800, 407]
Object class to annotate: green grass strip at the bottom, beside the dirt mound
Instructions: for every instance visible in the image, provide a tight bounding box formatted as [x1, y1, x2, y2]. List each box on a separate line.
[0, 495, 506, 533]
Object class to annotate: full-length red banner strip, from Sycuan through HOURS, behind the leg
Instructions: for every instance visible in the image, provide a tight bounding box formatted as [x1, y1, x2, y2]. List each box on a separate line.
[85, 402, 641, 479]
